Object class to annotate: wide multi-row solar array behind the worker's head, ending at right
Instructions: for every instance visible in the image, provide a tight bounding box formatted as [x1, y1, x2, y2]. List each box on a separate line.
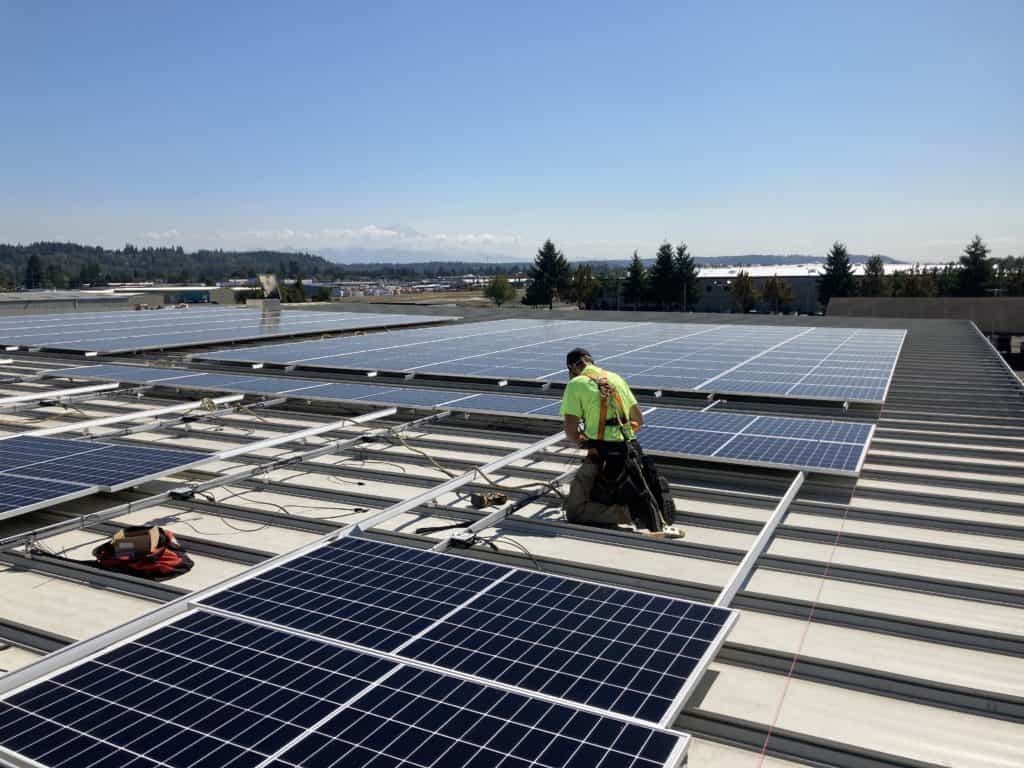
[193, 319, 905, 402]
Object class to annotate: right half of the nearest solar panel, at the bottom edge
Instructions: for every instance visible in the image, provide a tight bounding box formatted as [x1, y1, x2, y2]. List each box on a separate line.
[272, 667, 681, 768]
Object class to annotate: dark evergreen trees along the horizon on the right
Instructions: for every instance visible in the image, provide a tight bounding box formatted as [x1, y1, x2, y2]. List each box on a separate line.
[497, 236, 1024, 312]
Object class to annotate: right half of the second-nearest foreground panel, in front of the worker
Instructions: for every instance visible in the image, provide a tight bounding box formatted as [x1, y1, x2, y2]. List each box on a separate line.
[400, 571, 731, 721]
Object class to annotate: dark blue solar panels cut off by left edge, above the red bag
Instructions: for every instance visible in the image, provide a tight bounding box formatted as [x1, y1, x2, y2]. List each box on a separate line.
[0, 435, 210, 516]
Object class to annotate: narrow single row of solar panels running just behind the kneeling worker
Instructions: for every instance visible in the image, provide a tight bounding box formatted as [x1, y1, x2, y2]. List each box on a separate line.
[52, 366, 872, 475]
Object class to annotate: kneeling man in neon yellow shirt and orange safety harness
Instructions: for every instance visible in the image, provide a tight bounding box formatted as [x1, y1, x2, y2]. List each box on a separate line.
[561, 348, 681, 537]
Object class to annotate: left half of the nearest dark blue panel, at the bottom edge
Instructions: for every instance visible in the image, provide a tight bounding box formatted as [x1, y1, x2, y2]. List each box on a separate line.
[0, 614, 396, 768]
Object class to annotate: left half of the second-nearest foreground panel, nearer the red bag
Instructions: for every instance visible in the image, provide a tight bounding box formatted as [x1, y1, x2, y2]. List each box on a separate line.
[203, 538, 508, 650]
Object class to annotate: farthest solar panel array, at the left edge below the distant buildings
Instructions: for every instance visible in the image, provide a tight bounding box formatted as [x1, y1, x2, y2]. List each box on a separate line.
[0, 307, 458, 354]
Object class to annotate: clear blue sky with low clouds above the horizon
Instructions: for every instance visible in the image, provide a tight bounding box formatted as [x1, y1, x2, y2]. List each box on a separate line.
[0, 0, 1024, 261]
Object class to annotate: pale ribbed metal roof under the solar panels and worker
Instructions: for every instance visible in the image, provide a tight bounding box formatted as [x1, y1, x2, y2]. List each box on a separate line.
[0, 305, 1024, 768]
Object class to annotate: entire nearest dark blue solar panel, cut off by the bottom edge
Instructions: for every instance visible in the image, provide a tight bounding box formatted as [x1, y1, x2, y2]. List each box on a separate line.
[0, 612, 687, 768]
